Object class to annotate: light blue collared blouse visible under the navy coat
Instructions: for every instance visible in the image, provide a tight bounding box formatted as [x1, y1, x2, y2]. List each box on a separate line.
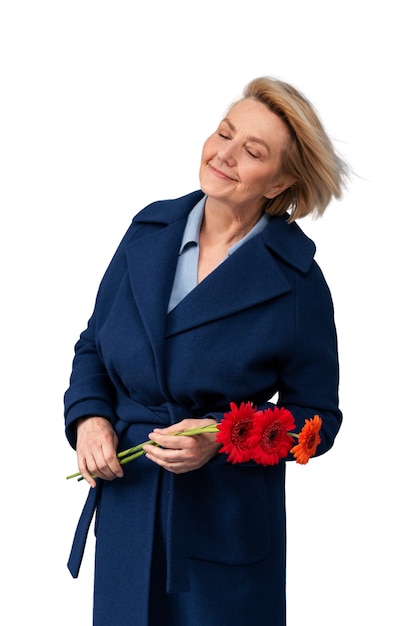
[168, 196, 270, 312]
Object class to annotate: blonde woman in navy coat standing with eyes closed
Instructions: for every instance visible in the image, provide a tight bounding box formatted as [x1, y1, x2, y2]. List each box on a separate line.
[65, 78, 344, 626]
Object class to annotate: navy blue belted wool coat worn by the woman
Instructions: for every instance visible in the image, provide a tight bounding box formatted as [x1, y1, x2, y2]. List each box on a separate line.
[65, 191, 341, 626]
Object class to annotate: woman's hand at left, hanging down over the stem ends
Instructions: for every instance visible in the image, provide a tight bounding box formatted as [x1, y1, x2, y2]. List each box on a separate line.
[76, 417, 123, 487]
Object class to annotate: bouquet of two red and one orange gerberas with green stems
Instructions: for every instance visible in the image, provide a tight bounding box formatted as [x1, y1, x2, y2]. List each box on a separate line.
[67, 402, 322, 480]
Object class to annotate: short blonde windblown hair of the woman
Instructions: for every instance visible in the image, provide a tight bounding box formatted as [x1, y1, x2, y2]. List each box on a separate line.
[243, 77, 347, 222]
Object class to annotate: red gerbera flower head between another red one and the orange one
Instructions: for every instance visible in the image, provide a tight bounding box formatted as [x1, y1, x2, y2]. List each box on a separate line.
[252, 407, 296, 465]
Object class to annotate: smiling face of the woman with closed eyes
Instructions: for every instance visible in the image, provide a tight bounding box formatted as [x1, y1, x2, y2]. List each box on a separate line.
[200, 99, 289, 211]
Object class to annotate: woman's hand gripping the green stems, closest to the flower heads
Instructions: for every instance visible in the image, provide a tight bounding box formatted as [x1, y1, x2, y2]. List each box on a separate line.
[144, 418, 221, 474]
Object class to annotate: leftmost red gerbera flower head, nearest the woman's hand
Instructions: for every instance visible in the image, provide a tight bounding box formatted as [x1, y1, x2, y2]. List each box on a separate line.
[216, 402, 257, 463]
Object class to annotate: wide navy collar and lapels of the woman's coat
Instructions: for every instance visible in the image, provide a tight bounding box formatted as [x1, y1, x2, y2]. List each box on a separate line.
[126, 191, 315, 344]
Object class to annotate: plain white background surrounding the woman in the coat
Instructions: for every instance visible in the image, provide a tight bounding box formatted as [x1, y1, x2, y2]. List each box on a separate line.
[0, 0, 418, 626]
